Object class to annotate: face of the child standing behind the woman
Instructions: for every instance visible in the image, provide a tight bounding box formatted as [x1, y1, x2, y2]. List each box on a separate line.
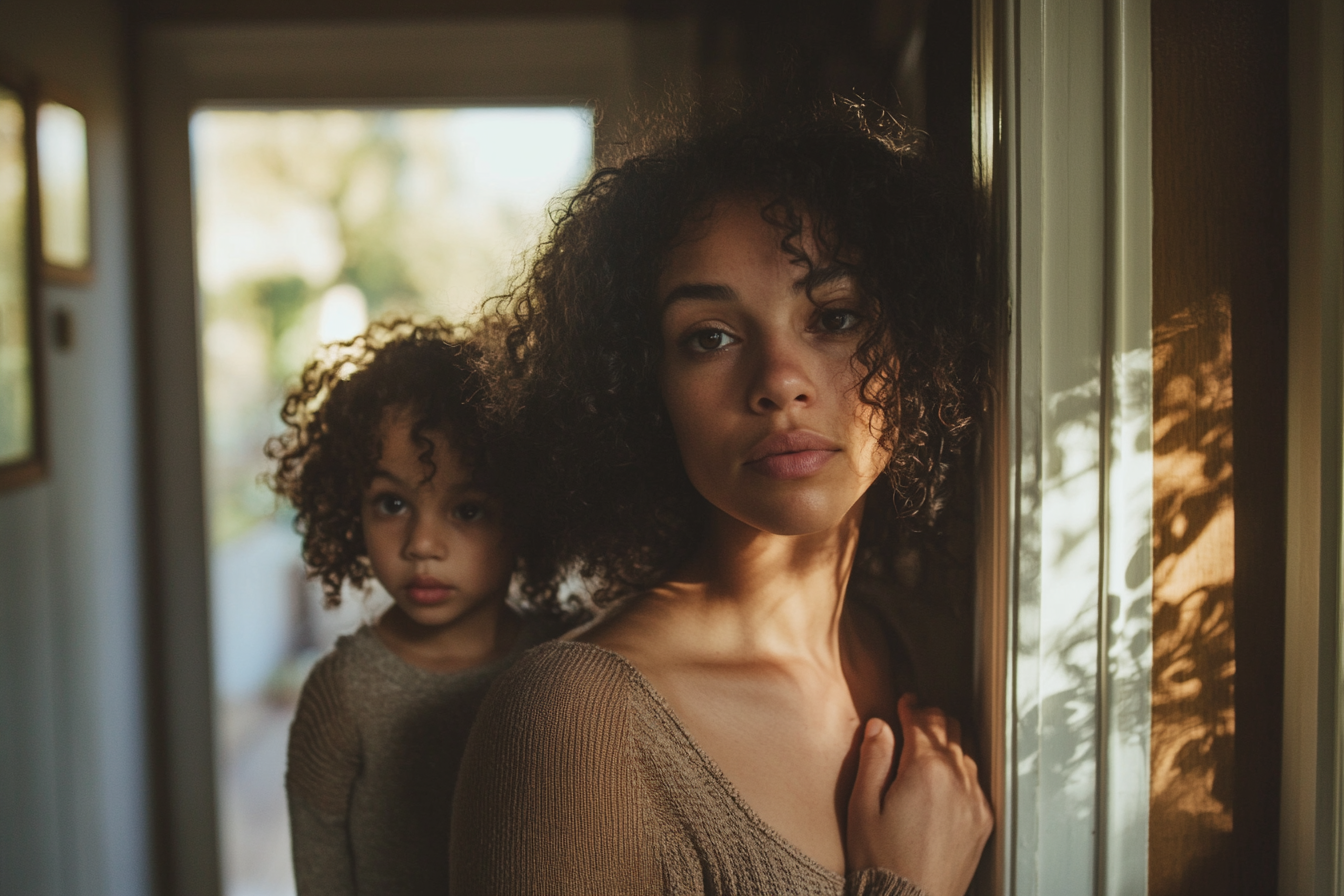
[363, 411, 515, 626]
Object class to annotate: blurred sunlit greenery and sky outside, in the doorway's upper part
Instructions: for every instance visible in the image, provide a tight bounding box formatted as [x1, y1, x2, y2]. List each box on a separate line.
[191, 106, 593, 545]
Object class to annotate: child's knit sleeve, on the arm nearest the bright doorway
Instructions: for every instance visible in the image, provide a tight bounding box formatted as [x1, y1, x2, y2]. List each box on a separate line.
[285, 649, 360, 896]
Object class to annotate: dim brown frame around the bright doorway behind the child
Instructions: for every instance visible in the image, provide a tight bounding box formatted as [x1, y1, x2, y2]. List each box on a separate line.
[134, 17, 694, 896]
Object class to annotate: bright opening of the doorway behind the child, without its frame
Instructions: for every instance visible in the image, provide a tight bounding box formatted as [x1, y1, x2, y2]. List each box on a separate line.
[191, 106, 593, 896]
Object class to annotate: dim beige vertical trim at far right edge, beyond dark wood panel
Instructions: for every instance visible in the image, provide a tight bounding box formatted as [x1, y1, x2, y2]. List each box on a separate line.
[1278, 0, 1344, 896]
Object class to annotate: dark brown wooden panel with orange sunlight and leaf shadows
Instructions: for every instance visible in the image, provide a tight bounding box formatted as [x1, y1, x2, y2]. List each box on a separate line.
[1149, 0, 1289, 896]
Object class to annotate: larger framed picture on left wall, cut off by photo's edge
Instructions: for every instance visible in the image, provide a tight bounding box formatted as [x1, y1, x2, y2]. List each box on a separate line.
[0, 69, 46, 489]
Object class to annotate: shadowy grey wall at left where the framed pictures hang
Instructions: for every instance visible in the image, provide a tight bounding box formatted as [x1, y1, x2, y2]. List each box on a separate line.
[0, 0, 149, 896]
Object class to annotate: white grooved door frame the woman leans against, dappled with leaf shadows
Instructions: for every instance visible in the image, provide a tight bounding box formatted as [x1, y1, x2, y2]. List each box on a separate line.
[973, 0, 1153, 896]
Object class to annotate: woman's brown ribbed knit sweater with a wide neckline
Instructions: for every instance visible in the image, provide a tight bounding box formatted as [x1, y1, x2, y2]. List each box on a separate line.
[450, 641, 923, 896]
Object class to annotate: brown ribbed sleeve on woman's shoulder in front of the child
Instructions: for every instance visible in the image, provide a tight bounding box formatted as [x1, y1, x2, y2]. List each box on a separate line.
[449, 642, 664, 896]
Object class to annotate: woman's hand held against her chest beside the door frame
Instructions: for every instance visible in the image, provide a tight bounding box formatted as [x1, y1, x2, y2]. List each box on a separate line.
[847, 693, 995, 896]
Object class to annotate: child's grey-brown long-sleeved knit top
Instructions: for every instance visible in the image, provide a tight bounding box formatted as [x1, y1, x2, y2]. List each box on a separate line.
[285, 621, 558, 896]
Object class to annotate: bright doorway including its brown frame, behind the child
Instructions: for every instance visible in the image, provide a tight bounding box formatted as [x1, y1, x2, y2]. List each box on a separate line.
[138, 17, 655, 896]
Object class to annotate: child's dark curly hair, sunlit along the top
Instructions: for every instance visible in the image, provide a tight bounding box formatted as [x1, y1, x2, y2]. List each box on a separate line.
[265, 318, 489, 607]
